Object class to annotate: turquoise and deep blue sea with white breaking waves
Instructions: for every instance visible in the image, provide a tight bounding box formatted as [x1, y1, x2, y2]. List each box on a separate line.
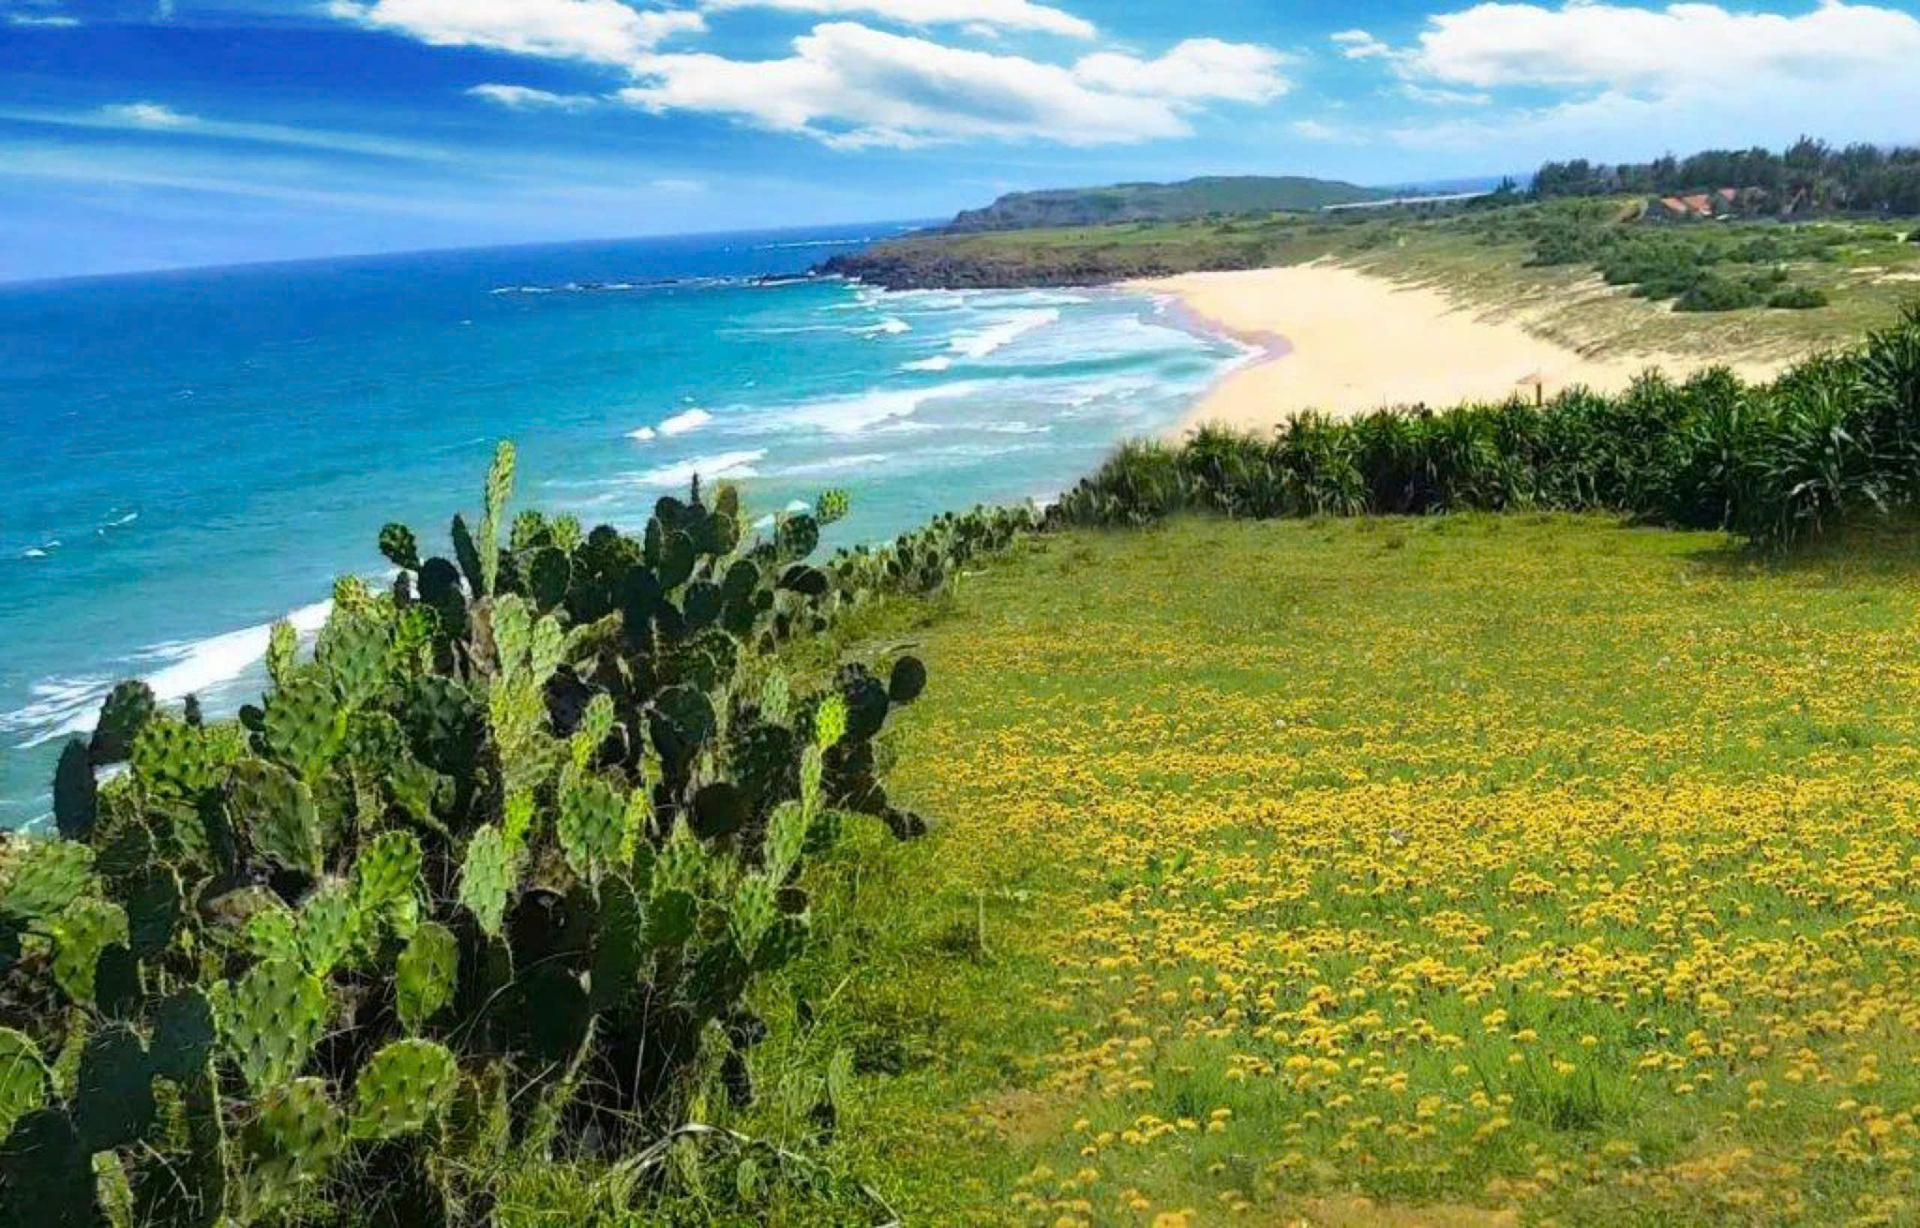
[0, 224, 1244, 827]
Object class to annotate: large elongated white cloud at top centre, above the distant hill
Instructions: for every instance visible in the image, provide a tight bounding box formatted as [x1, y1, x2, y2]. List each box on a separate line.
[620, 23, 1286, 150]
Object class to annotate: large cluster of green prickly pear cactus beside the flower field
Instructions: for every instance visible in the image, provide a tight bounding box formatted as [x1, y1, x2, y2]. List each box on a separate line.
[0, 445, 1023, 1226]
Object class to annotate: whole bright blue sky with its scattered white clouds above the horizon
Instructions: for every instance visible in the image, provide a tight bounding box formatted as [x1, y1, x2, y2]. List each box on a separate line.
[0, 0, 1920, 278]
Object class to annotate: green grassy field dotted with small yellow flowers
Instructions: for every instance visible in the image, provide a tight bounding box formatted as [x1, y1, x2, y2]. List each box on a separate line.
[753, 516, 1920, 1224]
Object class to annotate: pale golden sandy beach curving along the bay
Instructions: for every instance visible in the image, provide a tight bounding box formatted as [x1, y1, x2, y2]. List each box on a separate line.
[1131, 261, 1786, 434]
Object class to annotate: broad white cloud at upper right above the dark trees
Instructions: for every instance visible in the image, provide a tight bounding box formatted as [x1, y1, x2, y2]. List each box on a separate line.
[1390, 0, 1920, 163]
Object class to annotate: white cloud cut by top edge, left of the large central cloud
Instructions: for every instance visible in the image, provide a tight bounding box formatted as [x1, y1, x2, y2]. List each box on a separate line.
[328, 0, 707, 65]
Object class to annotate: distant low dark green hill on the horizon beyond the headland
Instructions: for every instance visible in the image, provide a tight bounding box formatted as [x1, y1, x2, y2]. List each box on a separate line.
[943, 175, 1386, 234]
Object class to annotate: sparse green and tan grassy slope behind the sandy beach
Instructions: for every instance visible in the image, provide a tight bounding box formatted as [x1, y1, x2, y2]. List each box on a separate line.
[860, 211, 1920, 357]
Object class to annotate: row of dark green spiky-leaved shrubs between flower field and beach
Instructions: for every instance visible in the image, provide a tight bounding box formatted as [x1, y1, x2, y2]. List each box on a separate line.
[1056, 305, 1920, 545]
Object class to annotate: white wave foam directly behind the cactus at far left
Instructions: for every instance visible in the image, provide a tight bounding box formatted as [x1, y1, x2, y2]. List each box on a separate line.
[0, 601, 334, 748]
